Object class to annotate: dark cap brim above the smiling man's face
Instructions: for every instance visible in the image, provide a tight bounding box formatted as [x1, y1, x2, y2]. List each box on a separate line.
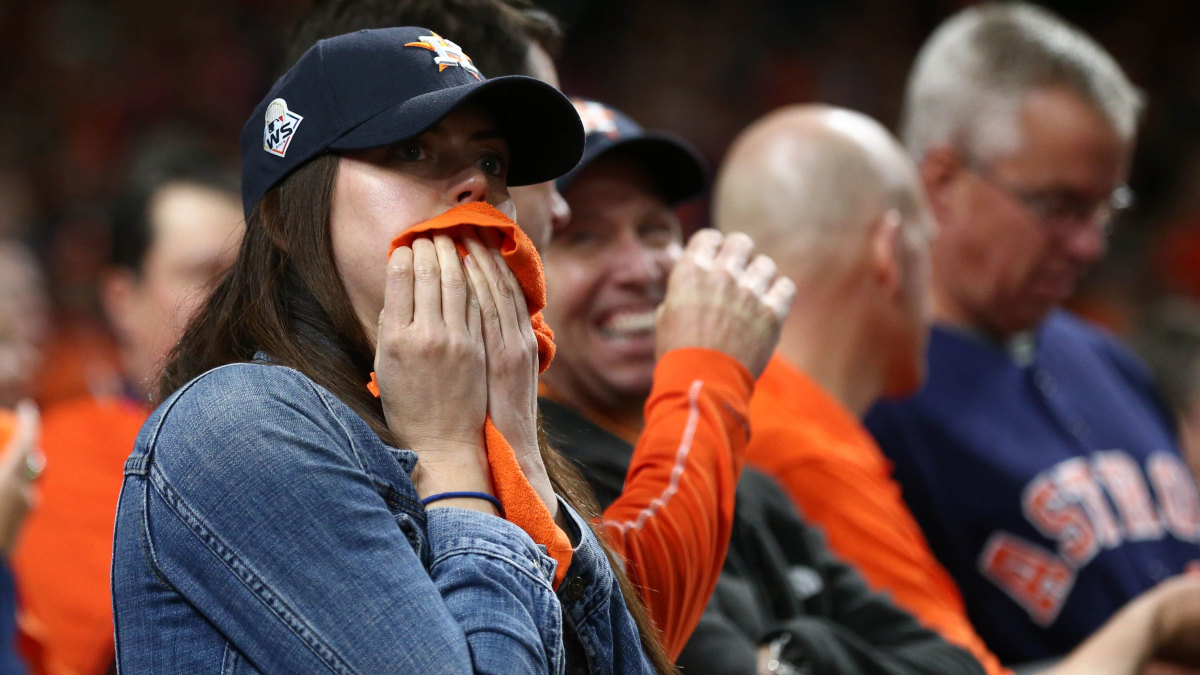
[558, 133, 708, 204]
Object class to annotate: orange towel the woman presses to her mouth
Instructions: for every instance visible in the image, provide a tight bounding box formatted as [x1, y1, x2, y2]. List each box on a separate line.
[367, 202, 574, 587]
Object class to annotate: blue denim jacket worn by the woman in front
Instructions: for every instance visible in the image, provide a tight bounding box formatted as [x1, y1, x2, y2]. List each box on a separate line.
[112, 355, 650, 674]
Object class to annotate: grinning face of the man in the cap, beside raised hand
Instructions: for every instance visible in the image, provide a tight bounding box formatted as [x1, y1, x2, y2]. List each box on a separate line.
[542, 153, 682, 408]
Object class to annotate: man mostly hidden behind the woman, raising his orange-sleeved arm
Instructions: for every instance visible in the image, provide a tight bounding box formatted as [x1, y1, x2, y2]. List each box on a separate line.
[279, 0, 782, 658]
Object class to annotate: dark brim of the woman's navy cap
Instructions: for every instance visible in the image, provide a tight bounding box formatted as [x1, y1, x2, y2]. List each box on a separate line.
[329, 76, 583, 185]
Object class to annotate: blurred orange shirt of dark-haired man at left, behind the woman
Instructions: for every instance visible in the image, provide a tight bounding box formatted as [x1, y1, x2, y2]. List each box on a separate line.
[12, 396, 149, 675]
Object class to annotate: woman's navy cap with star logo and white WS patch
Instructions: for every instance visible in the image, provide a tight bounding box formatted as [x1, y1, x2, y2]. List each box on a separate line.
[241, 26, 583, 217]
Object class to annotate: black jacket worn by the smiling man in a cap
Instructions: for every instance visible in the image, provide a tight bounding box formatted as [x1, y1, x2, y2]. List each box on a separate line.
[540, 399, 983, 675]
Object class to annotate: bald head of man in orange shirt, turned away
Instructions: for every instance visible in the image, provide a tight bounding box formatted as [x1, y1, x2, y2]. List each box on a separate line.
[713, 106, 932, 392]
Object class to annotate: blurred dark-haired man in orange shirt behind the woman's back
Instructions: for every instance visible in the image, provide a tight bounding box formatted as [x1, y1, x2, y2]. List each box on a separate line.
[13, 139, 244, 674]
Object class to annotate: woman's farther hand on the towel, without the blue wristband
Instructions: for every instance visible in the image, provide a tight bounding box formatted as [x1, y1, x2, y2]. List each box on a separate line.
[467, 231, 558, 516]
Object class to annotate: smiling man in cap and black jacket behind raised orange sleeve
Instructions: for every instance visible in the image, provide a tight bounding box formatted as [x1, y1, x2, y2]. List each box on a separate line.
[541, 98, 980, 674]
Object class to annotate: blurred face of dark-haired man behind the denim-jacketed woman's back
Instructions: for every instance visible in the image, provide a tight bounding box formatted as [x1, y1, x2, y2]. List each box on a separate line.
[104, 183, 245, 394]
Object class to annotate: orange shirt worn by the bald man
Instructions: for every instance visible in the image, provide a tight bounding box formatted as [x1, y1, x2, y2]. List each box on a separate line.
[746, 356, 1008, 675]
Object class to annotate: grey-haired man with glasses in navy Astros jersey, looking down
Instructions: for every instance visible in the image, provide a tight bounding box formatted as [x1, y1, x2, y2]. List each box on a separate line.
[866, 2, 1200, 663]
